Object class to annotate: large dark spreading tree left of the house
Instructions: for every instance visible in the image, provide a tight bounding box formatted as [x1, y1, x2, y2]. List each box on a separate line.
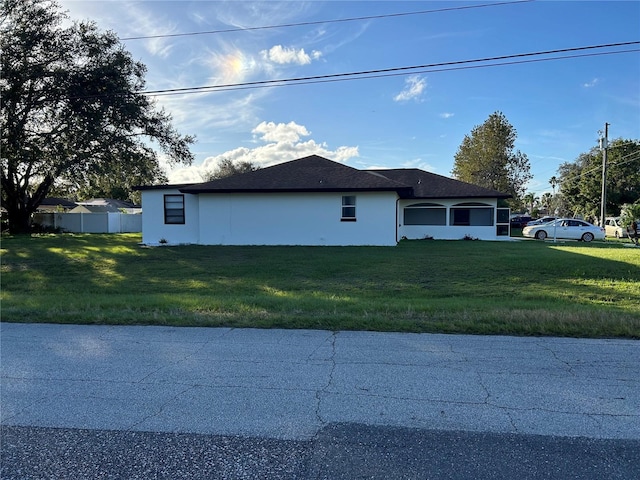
[0, 0, 194, 233]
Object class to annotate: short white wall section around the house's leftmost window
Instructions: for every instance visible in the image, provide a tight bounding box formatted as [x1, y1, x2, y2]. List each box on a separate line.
[142, 189, 199, 245]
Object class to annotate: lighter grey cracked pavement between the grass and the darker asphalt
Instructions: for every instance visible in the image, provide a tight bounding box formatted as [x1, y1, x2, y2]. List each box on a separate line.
[0, 323, 640, 478]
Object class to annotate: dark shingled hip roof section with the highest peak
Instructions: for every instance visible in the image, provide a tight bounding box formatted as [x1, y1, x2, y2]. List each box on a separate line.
[180, 155, 410, 194]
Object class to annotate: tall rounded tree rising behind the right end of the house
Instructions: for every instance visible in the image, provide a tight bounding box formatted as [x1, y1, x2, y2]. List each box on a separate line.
[452, 112, 533, 204]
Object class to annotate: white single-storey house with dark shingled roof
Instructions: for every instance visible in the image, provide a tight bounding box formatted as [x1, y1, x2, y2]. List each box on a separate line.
[138, 155, 510, 245]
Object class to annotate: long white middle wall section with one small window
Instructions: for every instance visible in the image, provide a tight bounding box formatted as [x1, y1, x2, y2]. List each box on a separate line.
[198, 192, 397, 245]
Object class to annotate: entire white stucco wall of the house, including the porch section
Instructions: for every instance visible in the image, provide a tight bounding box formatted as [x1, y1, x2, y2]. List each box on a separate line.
[142, 189, 509, 246]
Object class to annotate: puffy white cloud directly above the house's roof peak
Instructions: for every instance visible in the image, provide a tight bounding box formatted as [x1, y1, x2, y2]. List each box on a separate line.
[167, 122, 359, 184]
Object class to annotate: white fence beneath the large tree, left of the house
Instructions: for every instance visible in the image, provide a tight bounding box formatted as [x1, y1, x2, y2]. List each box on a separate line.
[33, 213, 142, 233]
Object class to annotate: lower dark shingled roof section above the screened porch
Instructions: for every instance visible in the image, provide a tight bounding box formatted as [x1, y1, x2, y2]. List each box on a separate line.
[375, 168, 511, 198]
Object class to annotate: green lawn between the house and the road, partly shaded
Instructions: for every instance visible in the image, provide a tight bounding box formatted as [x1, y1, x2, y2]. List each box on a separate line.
[0, 234, 640, 338]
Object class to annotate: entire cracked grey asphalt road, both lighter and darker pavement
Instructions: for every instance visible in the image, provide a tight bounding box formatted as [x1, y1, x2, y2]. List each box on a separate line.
[0, 323, 640, 480]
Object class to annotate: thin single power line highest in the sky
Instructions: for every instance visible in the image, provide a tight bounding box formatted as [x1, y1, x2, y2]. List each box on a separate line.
[120, 0, 536, 41]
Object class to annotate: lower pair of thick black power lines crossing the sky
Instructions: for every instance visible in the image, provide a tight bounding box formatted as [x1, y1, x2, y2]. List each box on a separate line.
[140, 41, 640, 95]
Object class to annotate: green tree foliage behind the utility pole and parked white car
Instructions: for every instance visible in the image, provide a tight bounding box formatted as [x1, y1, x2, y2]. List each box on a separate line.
[558, 139, 640, 217]
